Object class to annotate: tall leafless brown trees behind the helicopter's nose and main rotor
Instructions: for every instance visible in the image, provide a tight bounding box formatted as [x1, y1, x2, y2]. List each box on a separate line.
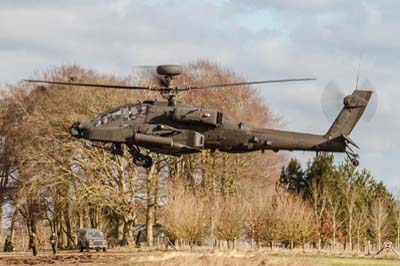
[0, 60, 282, 248]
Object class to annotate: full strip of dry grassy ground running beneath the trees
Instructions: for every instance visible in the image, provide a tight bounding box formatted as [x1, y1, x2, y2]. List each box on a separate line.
[0, 249, 400, 266]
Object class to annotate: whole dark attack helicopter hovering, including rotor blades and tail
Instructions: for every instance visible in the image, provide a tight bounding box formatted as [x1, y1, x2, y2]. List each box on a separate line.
[25, 65, 372, 168]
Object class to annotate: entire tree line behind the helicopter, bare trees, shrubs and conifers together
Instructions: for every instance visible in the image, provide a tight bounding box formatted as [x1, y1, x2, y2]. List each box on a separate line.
[0, 60, 400, 252]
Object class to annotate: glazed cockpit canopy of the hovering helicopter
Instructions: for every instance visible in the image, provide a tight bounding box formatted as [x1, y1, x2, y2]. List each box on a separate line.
[93, 103, 146, 127]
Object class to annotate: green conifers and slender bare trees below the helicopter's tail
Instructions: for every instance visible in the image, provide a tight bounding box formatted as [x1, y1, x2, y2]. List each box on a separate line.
[280, 154, 400, 251]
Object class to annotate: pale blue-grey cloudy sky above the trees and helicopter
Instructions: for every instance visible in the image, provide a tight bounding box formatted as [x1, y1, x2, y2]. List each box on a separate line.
[0, 0, 400, 190]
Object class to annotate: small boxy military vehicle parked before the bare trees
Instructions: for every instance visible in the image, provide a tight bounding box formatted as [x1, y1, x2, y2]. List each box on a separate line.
[78, 228, 107, 252]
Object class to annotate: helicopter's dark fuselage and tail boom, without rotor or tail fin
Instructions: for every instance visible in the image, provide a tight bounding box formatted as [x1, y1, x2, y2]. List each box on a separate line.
[71, 101, 346, 158]
